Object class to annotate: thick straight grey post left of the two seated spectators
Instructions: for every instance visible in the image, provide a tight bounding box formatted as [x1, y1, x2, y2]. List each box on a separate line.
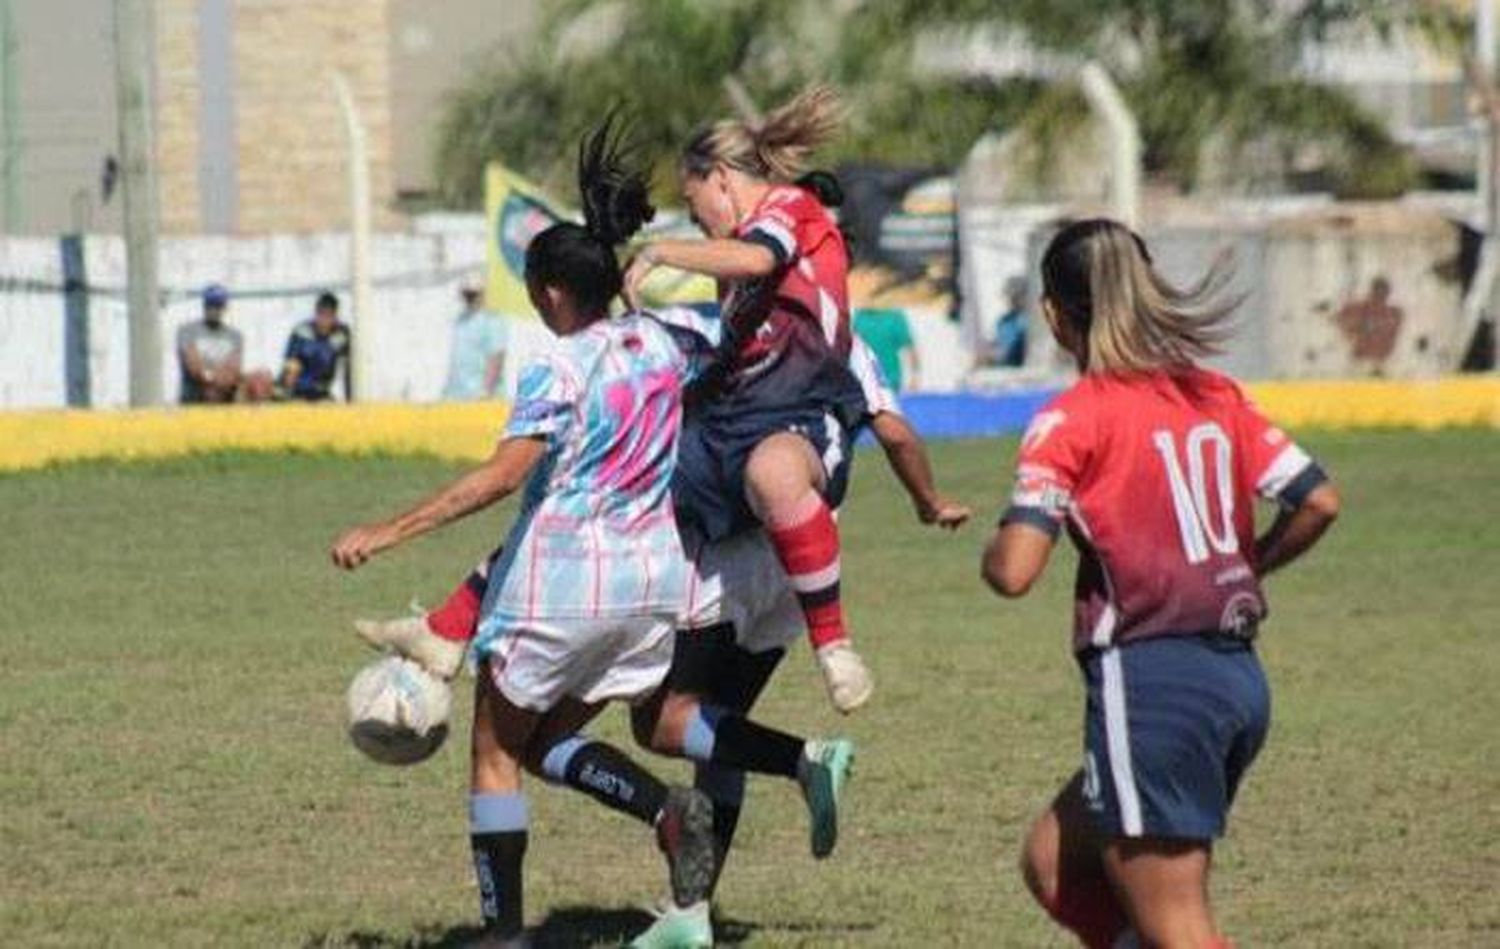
[114, 0, 162, 406]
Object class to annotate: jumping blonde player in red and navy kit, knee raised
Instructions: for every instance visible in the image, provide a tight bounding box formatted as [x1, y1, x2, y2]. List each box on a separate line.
[626, 87, 875, 712]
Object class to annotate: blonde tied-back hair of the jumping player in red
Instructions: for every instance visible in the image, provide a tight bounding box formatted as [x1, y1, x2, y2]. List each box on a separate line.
[683, 85, 843, 183]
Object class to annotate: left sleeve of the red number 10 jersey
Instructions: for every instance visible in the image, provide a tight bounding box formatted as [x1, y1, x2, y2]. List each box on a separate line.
[1001, 400, 1094, 537]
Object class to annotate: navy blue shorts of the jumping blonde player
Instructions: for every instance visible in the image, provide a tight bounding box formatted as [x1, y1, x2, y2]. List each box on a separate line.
[672, 408, 854, 541]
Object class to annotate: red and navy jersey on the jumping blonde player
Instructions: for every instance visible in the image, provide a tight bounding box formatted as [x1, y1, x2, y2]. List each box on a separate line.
[714, 184, 863, 415]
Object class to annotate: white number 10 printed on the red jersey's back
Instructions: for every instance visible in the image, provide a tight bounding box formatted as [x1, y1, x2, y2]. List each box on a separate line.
[1151, 421, 1239, 564]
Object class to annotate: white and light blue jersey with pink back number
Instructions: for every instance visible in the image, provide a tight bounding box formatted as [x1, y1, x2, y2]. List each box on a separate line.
[476, 307, 711, 655]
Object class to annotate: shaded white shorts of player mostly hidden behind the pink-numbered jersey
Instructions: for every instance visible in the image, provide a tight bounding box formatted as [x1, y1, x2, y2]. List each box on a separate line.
[678, 531, 807, 652]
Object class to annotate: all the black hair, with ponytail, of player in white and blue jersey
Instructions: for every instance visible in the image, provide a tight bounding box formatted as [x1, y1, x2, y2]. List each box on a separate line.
[527, 114, 656, 310]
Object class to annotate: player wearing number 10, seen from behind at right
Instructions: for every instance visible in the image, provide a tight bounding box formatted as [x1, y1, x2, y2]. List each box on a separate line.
[983, 220, 1338, 949]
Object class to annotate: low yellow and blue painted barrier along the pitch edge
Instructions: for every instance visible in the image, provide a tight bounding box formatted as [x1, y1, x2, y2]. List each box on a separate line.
[0, 376, 1500, 471]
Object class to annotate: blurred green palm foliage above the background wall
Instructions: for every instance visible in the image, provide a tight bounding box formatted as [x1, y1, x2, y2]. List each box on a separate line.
[437, 0, 1440, 205]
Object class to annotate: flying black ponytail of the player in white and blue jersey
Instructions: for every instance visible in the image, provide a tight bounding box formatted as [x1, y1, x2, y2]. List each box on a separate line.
[578, 112, 656, 247]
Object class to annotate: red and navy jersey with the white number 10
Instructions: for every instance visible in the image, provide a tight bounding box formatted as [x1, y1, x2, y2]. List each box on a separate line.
[1002, 369, 1325, 652]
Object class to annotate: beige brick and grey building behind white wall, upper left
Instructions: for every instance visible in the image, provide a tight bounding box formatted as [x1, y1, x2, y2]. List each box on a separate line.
[0, 0, 539, 234]
